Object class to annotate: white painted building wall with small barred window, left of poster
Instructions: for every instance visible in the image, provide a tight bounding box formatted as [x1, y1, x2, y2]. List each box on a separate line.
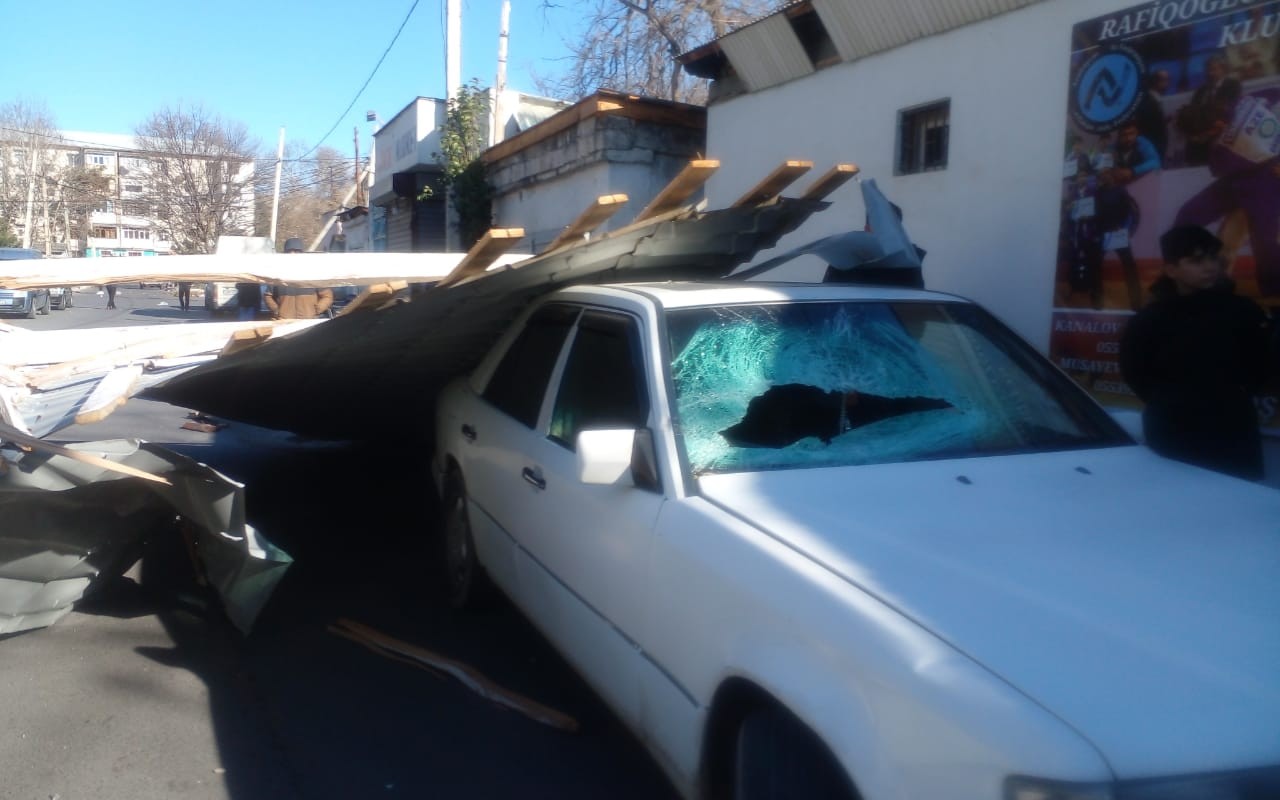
[707, 0, 1133, 351]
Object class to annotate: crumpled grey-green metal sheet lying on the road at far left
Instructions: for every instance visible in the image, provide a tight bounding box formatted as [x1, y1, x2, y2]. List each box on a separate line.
[0, 439, 292, 634]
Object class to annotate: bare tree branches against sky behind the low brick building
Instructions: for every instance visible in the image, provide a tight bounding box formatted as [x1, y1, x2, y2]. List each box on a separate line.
[539, 0, 783, 102]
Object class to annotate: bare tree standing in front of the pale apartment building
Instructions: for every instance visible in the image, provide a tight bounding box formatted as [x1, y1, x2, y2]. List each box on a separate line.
[134, 104, 257, 253]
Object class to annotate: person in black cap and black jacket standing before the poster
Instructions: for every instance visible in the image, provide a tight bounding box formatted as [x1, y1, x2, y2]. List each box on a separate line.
[1120, 225, 1267, 480]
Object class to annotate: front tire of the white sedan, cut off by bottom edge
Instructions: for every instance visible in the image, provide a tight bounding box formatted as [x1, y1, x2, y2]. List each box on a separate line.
[731, 705, 858, 800]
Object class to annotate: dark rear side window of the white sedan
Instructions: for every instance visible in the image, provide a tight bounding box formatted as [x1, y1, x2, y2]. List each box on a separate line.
[484, 303, 579, 428]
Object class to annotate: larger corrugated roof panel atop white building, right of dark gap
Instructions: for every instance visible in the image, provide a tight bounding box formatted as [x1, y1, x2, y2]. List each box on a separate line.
[808, 0, 1043, 62]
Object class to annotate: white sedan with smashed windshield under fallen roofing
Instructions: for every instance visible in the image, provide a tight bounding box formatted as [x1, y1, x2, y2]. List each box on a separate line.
[433, 283, 1280, 800]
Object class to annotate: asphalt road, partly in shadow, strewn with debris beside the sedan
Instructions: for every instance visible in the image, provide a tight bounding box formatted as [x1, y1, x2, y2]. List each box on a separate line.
[0, 287, 673, 800]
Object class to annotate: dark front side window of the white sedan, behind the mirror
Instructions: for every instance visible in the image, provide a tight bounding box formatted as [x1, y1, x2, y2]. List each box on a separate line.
[548, 311, 649, 449]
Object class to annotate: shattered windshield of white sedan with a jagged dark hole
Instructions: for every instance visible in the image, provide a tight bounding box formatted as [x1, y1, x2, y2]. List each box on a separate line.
[668, 301, 1129, 475]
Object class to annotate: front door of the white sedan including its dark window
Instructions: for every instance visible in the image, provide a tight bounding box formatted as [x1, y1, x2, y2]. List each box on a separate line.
[520, 308, 663, 723]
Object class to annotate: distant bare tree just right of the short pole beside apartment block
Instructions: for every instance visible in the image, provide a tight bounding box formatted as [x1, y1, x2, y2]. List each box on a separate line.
[253, 142, 356, 247]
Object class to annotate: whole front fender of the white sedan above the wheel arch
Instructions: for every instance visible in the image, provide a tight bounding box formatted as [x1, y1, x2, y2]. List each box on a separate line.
[646, 498, 1111, 800]
